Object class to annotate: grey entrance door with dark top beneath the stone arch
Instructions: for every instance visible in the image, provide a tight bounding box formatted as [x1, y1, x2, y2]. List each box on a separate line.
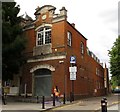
[34, 69, 52, 96]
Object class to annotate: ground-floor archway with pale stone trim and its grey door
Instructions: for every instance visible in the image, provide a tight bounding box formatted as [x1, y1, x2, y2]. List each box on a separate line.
[30, 64, 55, 96]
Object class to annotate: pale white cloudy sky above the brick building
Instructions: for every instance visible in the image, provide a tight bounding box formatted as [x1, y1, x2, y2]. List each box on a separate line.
[15, 0, 119, 77]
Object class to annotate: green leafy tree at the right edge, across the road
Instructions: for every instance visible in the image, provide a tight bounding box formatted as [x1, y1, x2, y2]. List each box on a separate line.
[109, 36, 120, 86]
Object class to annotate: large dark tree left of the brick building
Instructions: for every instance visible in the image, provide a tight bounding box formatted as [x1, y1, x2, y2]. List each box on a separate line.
[2, 2, 26, 80]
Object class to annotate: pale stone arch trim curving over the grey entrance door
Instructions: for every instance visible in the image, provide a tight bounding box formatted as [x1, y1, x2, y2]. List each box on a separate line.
[30, 64, 55, 73]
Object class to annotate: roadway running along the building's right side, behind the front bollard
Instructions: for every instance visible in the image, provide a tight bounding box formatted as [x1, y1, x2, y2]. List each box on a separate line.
[52, 94, 120, 112]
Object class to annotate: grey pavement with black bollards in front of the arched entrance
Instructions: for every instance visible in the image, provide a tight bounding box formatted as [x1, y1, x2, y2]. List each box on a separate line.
[1, 96, 70, 112]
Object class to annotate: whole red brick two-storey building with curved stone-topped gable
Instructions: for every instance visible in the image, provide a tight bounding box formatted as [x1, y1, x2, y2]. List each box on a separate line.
[16, 5, 108, 97]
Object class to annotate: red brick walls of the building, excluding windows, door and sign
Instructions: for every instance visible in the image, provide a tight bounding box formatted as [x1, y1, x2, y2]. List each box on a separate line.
[19, 5, 108, 98]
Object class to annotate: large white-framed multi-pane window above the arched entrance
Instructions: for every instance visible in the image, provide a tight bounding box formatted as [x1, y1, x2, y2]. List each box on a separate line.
[36, 27, 51, 46]
